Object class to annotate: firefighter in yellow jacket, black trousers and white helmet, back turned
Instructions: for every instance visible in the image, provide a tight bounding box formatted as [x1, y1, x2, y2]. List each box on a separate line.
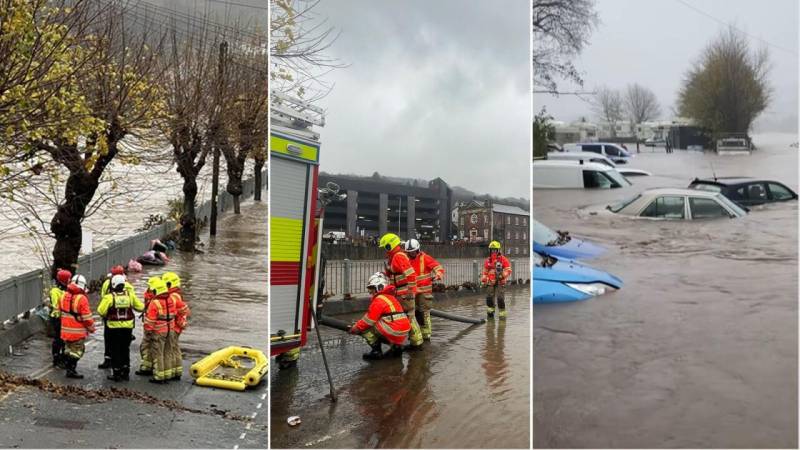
[97, 275, 144, 381]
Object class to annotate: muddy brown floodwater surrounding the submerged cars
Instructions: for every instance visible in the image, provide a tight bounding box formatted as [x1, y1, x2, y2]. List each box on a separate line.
[533, 135, 798, 448]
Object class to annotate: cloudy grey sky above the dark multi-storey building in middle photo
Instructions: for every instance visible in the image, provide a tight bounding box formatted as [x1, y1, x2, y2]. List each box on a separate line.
[317, 0, 531, 198]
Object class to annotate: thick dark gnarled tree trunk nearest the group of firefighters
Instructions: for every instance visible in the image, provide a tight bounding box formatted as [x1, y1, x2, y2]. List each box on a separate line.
[50, 171, 98, 275]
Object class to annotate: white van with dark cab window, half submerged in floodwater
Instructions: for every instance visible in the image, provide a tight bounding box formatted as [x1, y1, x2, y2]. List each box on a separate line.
[533, 160, 631, 189]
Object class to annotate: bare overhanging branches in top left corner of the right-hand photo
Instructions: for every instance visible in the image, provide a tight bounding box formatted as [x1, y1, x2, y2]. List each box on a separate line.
[532, 0, 597, 93]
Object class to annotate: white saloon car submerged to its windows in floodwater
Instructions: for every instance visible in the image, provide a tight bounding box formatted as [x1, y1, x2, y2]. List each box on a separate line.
[606, 188, 747, 220]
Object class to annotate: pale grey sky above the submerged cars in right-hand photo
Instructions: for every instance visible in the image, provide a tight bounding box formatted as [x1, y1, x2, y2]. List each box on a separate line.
[534, 0, 798, 131]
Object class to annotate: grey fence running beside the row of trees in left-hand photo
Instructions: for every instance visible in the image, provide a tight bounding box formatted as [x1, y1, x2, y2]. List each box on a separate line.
[0, 170, 267, 322]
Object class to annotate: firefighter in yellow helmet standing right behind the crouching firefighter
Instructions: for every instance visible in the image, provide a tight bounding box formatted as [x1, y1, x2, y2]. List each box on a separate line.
[378, 233, 423, 350]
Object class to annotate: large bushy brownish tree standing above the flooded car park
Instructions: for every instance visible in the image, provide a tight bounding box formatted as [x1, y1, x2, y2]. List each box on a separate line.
[678, 27, 772, 133]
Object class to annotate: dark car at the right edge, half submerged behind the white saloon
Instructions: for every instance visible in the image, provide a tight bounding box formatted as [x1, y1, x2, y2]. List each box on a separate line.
[689, 177, 797, 206]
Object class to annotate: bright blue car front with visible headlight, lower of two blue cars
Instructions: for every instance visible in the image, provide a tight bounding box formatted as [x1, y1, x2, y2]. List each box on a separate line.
[532, 252, 622, 304]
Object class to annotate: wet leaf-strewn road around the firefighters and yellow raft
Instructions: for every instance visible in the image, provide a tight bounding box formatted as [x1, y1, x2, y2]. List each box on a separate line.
[0, 202, 268, 448]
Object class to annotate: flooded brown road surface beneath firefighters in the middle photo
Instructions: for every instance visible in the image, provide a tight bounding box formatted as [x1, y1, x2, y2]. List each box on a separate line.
[271, 288, 530, 448]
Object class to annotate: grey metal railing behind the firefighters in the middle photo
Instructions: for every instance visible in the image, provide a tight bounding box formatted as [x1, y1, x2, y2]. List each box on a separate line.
[325, 259, 531, 298]
